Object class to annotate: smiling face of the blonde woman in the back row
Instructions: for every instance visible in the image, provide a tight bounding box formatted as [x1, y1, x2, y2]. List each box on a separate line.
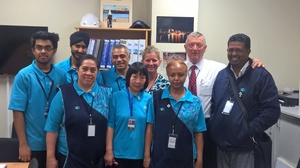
[142, 52, 161, 74]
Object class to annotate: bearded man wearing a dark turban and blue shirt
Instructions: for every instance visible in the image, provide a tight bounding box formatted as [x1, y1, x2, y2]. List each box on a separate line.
[56, 31, 103, 84]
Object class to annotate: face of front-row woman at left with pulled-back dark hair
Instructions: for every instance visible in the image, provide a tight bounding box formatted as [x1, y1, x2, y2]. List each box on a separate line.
[78, 59, 98, 88]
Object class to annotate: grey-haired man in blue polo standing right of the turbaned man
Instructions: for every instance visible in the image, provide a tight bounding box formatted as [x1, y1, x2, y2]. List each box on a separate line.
[101, 44, 130, 92]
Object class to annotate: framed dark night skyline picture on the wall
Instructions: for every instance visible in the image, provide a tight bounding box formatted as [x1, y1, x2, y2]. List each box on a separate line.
[156, 16, 194, 43]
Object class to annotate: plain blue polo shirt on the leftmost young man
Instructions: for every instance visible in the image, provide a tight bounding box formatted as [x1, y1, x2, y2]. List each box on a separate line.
[8, 60, 67, 151]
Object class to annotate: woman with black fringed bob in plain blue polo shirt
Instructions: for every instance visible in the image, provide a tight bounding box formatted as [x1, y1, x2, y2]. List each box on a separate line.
[104, 62, 152, 168]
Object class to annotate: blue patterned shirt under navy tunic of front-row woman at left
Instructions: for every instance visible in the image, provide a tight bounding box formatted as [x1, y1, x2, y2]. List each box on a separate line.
[45, 82, 111, 155]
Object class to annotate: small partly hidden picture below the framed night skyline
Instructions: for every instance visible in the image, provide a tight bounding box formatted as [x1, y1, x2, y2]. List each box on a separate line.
[161, 51, 186, 70]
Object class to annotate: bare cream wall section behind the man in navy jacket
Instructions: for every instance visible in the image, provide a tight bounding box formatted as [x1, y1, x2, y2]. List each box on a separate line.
[198, 0, 300, 89]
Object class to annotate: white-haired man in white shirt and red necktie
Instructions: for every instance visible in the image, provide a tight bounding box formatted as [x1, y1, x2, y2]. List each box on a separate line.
[184, 32, 264, 168]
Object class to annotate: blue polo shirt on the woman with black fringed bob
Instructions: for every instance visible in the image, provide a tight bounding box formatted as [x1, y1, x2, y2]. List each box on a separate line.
[108, 88, 152, 159]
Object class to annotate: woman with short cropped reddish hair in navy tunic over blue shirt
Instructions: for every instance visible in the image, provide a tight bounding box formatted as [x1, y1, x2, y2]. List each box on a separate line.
[144, 60, 206, 168]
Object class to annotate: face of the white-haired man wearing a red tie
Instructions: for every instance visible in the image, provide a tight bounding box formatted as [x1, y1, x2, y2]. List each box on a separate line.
[184, 36, 207, 64]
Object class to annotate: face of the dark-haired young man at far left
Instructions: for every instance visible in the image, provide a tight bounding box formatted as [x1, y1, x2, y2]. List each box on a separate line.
[31, 39, 56, 66]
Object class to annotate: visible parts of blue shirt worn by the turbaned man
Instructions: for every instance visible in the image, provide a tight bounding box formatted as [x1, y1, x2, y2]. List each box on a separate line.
[55, 56, 103, 84]
